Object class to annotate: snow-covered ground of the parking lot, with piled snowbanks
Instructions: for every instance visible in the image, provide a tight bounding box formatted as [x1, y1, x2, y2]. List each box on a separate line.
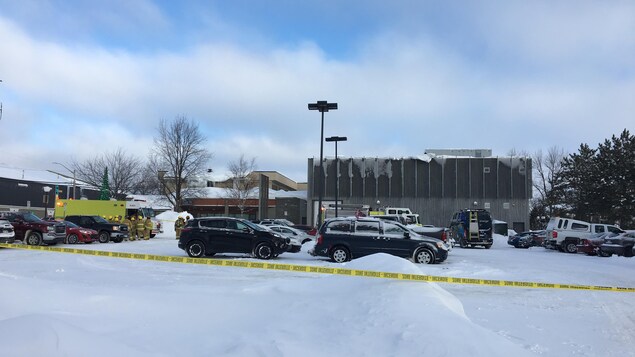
[0, 214, 635, 357]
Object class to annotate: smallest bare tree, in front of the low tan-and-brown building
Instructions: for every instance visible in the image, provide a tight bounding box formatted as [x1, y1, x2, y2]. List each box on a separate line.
[225, 154, 258, 215]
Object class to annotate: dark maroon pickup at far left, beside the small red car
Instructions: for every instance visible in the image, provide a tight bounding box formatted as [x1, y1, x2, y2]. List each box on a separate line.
[0, 212, 66, 245]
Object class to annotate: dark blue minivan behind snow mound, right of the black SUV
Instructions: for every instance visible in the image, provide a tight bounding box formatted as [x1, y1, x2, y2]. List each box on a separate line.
[309, 217, 448, 264]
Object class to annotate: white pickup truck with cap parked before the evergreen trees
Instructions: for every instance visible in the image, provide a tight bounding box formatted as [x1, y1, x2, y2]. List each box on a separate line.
[545, 217, 624, 253]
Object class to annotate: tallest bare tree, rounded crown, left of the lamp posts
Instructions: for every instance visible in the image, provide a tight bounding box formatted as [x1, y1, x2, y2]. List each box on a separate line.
[149, 116, 212, 211]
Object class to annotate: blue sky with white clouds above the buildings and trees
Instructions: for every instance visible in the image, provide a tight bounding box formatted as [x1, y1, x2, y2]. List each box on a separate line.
[0, 0, 635, 181]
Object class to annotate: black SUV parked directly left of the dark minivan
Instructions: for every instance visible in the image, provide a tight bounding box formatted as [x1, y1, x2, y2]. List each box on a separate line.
[179, 217, 289, 259]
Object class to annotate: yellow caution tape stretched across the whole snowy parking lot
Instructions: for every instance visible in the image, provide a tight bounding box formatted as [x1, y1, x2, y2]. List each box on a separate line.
[0, 243, 635, 293]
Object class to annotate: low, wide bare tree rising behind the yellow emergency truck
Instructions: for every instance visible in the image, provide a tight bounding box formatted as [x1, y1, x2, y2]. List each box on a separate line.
[71, 148, 142, 199]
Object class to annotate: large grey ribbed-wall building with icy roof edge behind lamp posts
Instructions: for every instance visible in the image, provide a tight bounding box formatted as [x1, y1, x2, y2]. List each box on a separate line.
[307, 150, 532, 232]
